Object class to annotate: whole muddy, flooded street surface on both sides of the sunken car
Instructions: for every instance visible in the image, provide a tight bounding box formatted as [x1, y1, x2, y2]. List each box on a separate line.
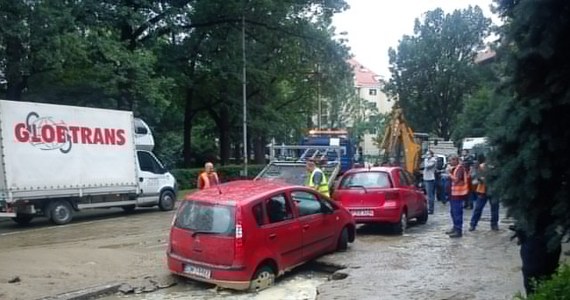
[0, 203, 568, 299]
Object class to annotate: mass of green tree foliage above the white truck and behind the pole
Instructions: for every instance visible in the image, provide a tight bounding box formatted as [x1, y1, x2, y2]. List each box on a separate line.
[0, 0, 353, 166]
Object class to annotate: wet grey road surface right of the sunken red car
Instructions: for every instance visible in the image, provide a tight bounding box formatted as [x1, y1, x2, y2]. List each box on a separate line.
[318, 203, 523, 300]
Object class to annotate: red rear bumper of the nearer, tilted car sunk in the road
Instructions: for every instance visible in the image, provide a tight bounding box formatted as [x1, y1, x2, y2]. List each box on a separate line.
[166, 253, 253, 290]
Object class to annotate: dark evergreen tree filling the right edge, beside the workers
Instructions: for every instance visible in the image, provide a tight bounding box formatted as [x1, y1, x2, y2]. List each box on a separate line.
[490, 0, 570, 293]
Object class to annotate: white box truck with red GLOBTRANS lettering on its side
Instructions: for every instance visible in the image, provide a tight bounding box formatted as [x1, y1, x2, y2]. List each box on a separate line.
[0, 100, 176, 225]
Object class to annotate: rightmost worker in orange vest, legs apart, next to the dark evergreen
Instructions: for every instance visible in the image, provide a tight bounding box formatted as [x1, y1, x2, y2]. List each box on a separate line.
[469, 154, 499, 231]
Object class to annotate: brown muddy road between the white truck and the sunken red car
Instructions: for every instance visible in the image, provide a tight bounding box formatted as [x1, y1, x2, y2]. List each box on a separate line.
[0, 209, 172, 299]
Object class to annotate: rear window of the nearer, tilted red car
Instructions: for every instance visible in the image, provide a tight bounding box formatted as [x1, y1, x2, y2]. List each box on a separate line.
[175, 200, 235, 234]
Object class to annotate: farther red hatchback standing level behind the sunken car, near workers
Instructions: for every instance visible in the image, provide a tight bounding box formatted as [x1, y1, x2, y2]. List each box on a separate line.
[332, 167, 428, 233]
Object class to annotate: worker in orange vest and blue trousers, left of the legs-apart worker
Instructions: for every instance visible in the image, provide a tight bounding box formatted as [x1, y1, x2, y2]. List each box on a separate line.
[446, 155, 469, 238]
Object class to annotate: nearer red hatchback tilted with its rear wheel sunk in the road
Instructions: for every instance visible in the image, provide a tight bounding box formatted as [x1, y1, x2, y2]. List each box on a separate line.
[167, 180, 355, 291]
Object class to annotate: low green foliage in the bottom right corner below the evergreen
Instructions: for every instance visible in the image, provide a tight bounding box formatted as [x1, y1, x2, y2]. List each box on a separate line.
[516, 264, 570, 300]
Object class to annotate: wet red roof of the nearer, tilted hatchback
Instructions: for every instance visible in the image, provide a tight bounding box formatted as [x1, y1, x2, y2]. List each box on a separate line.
[185, 180, 291, 202]
